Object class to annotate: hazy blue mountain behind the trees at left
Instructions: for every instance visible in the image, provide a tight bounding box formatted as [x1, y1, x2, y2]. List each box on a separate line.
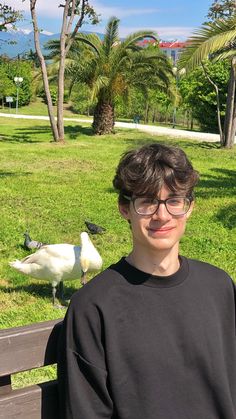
[0, 30, 104, 58]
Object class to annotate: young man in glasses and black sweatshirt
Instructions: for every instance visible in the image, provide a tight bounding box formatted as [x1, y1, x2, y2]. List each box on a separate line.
[58, 144, 236, 419]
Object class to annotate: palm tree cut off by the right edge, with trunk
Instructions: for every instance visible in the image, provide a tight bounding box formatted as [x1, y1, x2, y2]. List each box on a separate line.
[178, 14, 236, 148]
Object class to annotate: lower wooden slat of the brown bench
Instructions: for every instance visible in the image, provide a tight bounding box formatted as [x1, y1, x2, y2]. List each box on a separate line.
[0, 381, 59, 419]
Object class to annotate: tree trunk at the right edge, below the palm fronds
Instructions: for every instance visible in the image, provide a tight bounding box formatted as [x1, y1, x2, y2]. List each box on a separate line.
[223, 57, 236, 148]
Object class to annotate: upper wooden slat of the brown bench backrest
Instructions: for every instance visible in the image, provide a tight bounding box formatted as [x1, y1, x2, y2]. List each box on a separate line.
[0, 319, 61, 377]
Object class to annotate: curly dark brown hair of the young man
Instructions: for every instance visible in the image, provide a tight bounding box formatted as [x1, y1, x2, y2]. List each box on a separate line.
[113, 143, 199, 204]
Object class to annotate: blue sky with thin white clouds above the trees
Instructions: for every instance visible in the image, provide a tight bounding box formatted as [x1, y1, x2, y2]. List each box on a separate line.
[6, 0, 213, 40]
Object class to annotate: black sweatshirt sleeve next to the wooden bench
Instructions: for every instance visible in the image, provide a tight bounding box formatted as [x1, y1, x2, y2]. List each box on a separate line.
[58, 290, 114, 419]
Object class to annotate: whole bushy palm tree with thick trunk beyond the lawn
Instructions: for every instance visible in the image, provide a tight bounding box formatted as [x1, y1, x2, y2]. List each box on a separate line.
[48, 17, 171, 134]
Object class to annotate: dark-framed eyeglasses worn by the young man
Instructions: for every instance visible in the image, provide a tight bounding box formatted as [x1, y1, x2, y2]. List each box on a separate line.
[124, 195, 192, 215]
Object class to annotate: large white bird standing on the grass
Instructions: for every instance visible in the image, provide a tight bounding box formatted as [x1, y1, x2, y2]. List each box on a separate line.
[9, 232, 102, 305]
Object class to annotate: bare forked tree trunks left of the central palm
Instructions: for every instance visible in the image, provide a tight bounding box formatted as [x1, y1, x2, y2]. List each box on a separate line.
[27, 0, 97, 142]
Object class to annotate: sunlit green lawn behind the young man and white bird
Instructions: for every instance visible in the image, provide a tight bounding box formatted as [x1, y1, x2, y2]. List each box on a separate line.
[0, 118, 236, 386]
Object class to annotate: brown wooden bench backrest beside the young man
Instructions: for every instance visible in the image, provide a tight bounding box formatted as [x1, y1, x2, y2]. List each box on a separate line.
[0, 320, 61, 419]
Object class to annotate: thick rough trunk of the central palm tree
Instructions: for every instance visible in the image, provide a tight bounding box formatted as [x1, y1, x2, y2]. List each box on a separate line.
[92, 99, 115, 135]
